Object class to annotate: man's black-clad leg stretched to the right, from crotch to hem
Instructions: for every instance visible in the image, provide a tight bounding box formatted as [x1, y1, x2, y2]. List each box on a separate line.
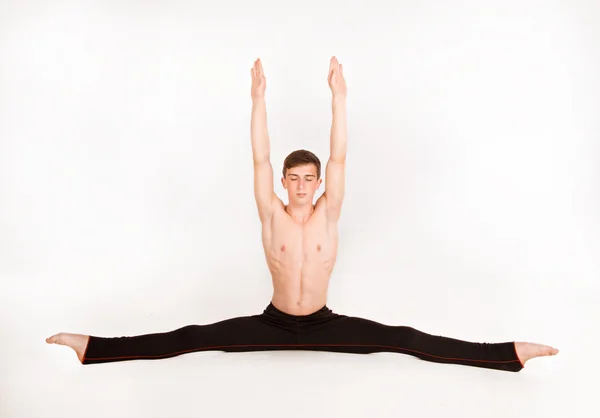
[299, 313, 550, 372]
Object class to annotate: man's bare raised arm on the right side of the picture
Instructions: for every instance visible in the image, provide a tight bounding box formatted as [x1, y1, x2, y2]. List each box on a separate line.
[325, 57, 348, 221]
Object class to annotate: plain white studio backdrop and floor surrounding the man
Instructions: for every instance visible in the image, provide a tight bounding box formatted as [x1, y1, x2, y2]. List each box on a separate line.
[0, 0, 600, 418]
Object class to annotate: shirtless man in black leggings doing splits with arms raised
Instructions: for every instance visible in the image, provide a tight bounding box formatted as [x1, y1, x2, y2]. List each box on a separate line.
[46, 57, 558, 372]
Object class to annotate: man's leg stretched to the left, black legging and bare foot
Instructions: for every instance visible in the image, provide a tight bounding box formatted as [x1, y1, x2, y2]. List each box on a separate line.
[47, 306, 298, 364]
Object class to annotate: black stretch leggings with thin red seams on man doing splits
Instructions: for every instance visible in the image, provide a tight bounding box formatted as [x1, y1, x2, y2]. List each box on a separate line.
[82, 303, 523, 372]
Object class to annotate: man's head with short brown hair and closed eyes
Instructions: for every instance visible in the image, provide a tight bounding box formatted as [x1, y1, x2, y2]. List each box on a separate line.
[281, 149, 323, 205]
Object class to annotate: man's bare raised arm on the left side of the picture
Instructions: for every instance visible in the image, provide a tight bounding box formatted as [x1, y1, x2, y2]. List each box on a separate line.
[250, 58, 276, 222]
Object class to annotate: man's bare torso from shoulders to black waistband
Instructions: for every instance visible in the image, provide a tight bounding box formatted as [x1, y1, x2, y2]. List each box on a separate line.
[262, 196, 338, 315]
